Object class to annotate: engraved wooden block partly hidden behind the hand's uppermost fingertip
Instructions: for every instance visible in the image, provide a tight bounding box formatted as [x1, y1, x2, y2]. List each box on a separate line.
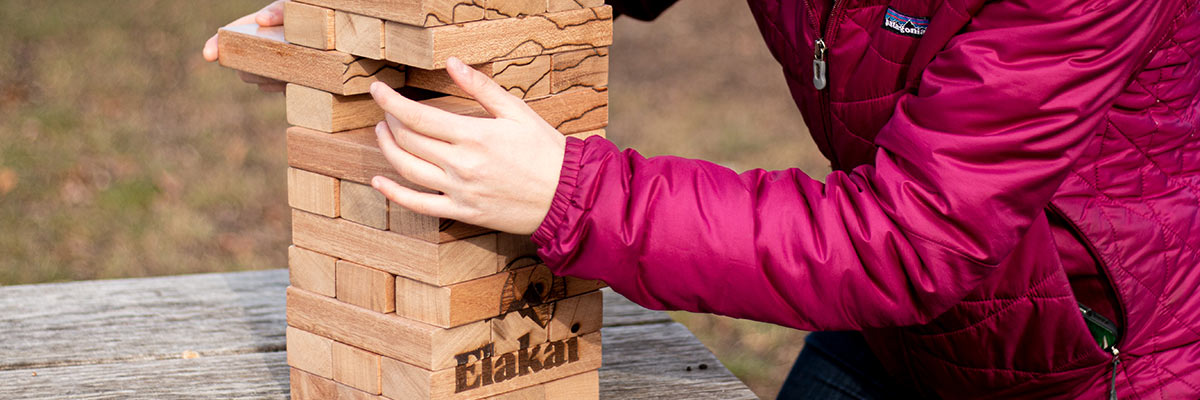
[406, 55, 551, 100]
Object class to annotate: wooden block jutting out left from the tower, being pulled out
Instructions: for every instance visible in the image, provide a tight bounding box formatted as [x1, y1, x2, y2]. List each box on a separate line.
[217, 24, 404, 95]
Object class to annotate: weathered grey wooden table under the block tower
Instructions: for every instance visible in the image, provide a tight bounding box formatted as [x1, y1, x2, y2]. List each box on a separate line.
[0, 269, 755, 399]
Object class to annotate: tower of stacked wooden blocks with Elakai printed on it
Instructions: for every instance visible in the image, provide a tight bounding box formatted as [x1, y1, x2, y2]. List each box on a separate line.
[218, 0, 612, 400]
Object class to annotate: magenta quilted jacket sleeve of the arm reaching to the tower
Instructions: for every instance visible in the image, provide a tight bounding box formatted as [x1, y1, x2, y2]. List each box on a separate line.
[534, 0, 1172, 330]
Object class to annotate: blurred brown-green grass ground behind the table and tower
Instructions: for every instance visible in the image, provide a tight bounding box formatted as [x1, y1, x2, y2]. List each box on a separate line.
[0, 0, 828, 398]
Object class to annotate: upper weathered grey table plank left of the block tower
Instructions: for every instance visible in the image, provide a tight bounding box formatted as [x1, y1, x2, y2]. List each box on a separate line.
[0, 270, 288, 370]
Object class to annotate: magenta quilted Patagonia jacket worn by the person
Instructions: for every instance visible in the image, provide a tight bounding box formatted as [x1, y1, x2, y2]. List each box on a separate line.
[534, 0, 1200, 399]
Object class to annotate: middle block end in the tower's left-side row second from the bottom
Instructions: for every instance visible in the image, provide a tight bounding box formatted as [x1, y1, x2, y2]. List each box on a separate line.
[337, 261, 396, 312]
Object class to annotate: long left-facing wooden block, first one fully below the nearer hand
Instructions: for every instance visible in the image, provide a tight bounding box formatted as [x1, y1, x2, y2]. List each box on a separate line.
[292, 210, 502, 286]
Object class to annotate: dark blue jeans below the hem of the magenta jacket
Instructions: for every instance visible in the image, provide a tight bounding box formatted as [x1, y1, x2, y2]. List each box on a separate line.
[779, 332, 918, 400]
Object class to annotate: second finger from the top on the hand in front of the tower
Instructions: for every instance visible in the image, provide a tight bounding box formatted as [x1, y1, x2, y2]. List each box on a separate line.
[371, 82, 472, 143]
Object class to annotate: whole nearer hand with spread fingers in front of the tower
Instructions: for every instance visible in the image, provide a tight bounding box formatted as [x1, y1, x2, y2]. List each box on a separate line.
[371, 58, 566, 234]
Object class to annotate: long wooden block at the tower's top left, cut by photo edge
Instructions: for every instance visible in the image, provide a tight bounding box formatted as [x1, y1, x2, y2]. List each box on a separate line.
[302, 0, 484, 26]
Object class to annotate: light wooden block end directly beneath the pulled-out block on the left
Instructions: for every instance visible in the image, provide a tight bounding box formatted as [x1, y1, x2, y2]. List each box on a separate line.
[286, 83, 383, 132]
